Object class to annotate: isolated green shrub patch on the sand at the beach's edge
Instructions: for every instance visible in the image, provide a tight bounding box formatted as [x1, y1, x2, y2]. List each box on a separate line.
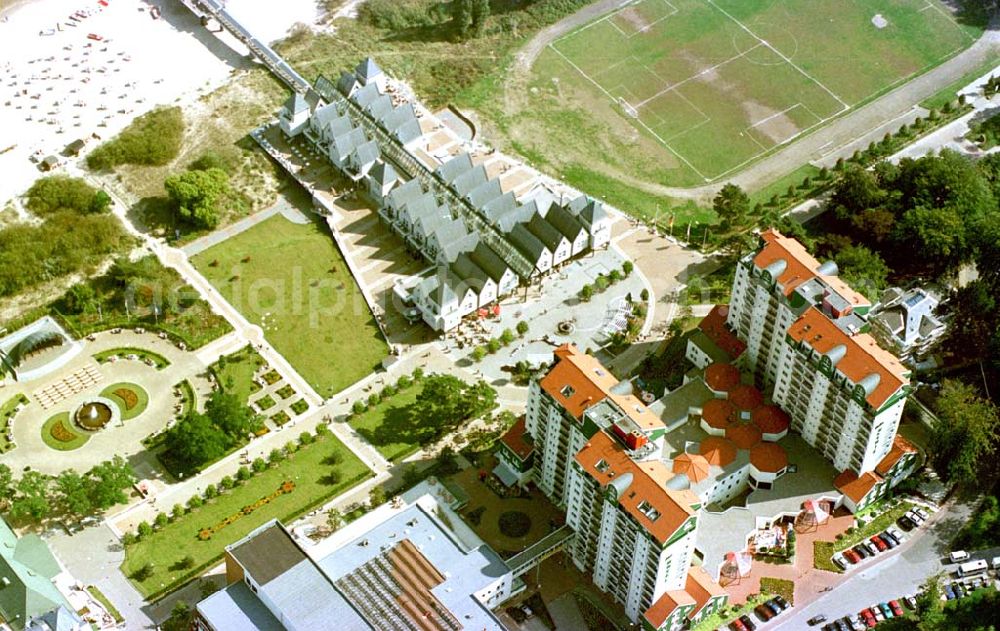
[87, 107, 184, 171]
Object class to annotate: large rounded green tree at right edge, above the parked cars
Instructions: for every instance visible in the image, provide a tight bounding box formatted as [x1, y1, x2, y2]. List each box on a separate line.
[929, 379, 1000, 486]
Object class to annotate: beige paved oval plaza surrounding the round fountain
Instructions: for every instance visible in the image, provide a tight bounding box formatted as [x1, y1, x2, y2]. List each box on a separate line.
[0, 329, 221, 479]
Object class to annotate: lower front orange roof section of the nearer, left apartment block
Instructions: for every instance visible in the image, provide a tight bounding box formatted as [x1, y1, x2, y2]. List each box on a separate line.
[576, 432, 701, 544]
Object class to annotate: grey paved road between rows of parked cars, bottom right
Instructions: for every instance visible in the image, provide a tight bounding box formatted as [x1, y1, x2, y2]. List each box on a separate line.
[764, 499, 978, 631]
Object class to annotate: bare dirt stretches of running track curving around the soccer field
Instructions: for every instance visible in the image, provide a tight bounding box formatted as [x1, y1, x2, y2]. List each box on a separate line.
[504, 0, 1000, 202]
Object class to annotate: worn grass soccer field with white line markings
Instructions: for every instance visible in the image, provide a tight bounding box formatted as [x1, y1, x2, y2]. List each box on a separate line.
[548, 0, 980, 182]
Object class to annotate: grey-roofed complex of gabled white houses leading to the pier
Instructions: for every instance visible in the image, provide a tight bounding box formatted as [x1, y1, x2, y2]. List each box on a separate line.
[279, 59, 611, 331]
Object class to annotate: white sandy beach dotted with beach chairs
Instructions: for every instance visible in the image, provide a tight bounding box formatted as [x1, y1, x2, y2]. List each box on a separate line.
[0, 0, 317, 207]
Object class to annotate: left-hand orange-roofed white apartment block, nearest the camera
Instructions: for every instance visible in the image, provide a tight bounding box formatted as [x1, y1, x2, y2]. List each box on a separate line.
[516, 345, 727, 631]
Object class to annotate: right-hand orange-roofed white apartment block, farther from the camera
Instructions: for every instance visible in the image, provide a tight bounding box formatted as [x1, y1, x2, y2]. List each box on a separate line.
[726, 230, 912, 508]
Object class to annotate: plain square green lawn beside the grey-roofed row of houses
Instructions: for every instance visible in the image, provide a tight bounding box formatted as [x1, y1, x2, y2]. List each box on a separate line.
[192, 215, 387, 397]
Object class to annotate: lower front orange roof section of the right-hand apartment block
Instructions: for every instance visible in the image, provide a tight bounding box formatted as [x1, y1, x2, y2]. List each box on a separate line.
[788, 307, 910, 409]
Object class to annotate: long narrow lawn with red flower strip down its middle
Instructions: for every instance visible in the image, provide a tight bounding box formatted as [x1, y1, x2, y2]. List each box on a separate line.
[121, 434, 371, 598]
